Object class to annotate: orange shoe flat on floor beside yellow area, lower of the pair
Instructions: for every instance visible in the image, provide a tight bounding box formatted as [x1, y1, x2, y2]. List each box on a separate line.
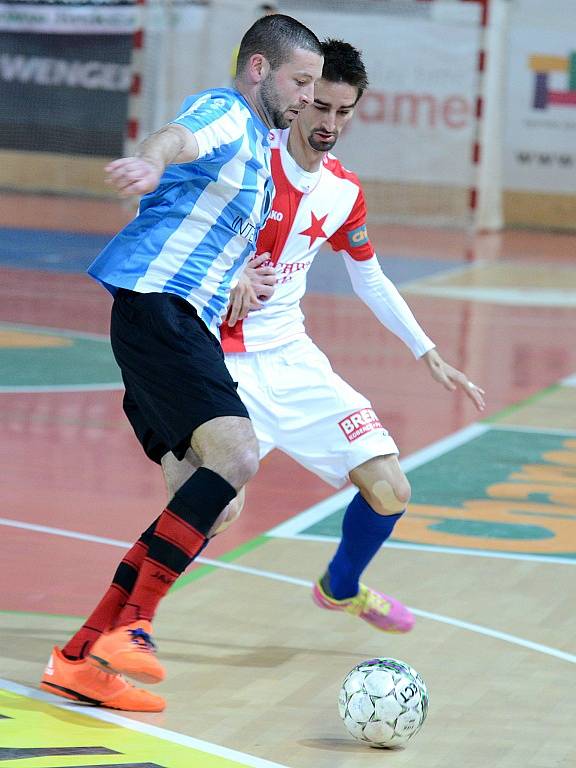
[40, 646, 166, 712]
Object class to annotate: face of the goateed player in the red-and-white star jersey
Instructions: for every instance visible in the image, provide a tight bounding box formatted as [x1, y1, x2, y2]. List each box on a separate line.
[297, 79, 358, 152]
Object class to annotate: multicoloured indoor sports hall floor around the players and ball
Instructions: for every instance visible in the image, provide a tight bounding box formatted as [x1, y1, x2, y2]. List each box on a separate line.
[0, 195, 576, 768]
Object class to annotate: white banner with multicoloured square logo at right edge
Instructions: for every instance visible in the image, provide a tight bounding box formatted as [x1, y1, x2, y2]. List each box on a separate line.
[504, 24, 576, 194]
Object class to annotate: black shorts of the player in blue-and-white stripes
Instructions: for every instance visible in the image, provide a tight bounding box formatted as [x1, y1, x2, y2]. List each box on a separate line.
[110, 288, 249, 463]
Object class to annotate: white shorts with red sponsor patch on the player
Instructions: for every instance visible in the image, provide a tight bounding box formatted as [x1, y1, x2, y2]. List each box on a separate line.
[226, 336, 398, 488]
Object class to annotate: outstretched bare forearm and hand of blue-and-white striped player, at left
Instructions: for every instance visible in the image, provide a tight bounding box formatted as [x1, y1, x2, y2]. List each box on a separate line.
[106, 123, 199, 197]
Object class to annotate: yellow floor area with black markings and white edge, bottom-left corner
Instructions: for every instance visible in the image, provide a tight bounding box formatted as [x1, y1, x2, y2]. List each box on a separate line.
[0, 679, 287, 768]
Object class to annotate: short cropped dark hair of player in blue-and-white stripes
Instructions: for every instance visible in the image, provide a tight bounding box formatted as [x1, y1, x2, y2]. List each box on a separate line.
[237, 13, 322, 72]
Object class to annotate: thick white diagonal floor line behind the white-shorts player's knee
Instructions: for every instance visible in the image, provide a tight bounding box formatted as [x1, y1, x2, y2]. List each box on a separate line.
[266, 424, 492, 538]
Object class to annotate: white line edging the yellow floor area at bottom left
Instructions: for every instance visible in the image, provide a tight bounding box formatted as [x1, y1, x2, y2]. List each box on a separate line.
[0, 678, 287, 768]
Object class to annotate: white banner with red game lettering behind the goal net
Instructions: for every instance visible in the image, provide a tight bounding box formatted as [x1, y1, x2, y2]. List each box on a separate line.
[286, 3, 480, 187]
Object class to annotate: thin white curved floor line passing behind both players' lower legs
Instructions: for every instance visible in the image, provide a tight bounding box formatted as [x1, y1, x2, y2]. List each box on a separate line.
[0, 518, 576, 664]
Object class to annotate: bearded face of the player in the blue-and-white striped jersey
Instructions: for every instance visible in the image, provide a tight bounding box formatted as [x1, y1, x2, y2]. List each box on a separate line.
[260, 48, 322, 128]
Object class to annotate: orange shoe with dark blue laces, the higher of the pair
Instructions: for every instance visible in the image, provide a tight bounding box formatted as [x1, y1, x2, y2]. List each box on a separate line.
[88, 620, 165, 683]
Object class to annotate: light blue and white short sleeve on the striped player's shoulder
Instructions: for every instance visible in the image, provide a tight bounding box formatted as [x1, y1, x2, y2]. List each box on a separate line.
[172, 92, 246, 159]
